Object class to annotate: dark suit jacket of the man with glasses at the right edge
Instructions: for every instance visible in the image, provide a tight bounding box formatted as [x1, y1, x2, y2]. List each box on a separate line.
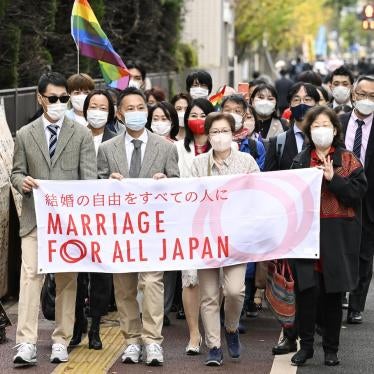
[339, 112, 374, 238]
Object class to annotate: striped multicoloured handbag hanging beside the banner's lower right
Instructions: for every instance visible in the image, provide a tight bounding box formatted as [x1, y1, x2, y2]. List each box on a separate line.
[265, 260, 296, 328]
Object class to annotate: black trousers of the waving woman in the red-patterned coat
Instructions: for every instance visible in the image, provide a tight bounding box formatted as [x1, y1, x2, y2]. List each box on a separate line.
[295, 272, 343, 353]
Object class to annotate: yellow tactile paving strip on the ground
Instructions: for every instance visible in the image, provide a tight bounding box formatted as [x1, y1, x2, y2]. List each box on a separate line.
[52, 313, 125, 374]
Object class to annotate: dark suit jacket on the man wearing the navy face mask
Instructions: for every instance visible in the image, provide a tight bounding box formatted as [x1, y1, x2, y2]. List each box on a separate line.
[264, 127, 298, 171]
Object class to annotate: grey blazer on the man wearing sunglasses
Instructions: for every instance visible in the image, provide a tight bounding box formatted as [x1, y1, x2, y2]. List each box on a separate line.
[10, 117, 97, 237]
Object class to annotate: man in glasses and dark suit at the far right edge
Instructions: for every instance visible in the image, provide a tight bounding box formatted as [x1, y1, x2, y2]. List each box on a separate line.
[340, 76, 374, 324]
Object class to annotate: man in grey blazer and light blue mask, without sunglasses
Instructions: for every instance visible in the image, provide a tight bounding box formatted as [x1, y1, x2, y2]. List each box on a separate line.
[97, 87, 179, 365]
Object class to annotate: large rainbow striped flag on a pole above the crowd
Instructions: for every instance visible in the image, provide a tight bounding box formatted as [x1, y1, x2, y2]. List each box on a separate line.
[71, 0, 130, 90]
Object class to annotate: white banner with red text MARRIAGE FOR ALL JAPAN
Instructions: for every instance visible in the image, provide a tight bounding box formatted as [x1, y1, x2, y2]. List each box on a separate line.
[34, 169, 322, 273]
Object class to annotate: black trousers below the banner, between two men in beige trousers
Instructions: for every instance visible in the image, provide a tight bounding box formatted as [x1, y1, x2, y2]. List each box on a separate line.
[75, 273, 112, 320]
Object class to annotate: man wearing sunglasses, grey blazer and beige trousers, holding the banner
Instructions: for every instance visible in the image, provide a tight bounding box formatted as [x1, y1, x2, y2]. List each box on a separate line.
[11, 73, 97, 365]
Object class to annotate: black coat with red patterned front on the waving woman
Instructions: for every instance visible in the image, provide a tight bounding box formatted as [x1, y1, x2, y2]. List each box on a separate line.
[289, 147, 367, 293]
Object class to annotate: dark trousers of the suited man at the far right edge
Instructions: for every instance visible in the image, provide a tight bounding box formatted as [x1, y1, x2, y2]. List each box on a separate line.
[348, 228, 374, 312]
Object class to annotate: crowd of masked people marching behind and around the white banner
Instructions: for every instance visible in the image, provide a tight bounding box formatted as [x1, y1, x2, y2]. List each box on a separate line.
[11, 63, 374, 366]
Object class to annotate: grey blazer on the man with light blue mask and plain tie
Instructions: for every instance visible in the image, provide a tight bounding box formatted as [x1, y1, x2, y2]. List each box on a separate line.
[97, 130, 179, 179]
